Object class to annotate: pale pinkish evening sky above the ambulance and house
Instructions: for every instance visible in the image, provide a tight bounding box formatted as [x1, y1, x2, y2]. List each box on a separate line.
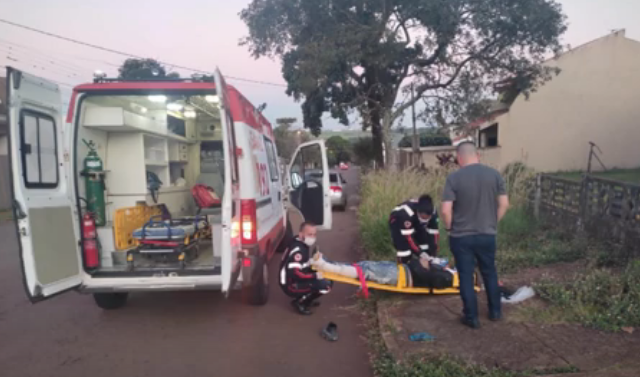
[0, 0, 640, 130]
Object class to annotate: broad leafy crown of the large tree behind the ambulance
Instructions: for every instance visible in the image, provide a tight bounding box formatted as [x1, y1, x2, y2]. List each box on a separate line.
[240, 0, 566, 163]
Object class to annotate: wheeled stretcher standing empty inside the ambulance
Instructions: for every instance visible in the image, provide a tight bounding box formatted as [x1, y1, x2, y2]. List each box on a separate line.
[127, 215, 209, 270]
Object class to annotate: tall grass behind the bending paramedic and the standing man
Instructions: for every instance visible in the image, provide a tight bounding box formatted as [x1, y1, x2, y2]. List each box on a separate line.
[358, 164, 585, 273]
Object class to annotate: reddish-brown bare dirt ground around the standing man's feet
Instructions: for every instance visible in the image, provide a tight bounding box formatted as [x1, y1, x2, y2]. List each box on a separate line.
[378, 263, 640, 377]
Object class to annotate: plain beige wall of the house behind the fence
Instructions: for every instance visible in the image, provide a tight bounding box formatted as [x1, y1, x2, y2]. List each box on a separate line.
[497, 32, 640, 171]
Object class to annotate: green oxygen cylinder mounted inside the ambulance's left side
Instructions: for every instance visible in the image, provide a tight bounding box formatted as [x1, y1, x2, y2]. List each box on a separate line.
[81, 139, 107, 226]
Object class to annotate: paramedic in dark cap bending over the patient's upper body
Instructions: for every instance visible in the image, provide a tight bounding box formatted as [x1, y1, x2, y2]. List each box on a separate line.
[389, 195, 440, 286]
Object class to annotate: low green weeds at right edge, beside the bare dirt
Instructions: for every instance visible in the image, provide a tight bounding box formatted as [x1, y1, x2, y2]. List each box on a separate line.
[535, 261, 640, 332]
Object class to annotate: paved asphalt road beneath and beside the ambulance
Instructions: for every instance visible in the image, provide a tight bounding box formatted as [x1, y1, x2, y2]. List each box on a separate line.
[0, 168, 371, 377]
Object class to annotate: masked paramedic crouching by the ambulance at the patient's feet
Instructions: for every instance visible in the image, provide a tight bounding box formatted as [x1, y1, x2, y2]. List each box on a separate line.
[280, 222, 332, 315]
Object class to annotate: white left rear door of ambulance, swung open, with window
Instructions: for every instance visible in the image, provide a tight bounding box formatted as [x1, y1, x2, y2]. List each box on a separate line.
[7, 68, 82, 301]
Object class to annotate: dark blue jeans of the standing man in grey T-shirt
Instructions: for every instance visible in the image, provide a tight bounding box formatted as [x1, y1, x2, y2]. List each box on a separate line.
[449, 235, 501, 320]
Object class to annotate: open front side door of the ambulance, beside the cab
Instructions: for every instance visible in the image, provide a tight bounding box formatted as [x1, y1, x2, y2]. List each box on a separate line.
[288, 140, 332, 230]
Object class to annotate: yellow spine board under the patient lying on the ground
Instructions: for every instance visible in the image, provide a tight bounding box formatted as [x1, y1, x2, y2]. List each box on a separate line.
[320, 264, 480, 297]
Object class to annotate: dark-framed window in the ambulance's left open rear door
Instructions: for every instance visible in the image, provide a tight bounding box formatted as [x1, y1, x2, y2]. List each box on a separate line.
[20, 110, 58, 188]
